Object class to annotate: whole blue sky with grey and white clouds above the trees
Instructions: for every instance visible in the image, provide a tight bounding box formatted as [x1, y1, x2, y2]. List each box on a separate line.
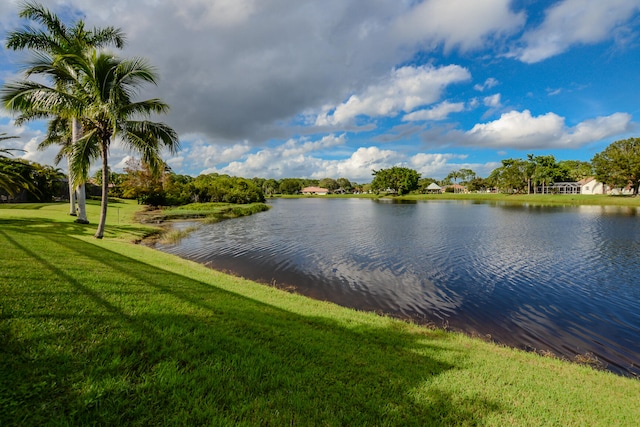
[0, 0, 640, 183]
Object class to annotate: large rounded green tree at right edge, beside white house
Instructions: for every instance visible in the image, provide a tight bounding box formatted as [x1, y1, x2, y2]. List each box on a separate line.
[591, 138, 640, 196]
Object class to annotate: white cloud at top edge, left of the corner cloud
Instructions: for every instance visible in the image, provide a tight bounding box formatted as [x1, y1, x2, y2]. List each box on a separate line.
[395, 0, 525, 51]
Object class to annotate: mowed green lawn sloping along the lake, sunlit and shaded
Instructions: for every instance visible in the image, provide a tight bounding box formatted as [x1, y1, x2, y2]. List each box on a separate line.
[0, 203, 640, 426]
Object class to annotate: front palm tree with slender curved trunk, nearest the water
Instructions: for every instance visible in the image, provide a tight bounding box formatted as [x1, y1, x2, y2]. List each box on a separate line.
[2, 50, 179, 238]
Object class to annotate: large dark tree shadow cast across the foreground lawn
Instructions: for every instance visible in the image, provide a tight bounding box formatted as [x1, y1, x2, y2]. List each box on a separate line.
[0, 223, 501, 425]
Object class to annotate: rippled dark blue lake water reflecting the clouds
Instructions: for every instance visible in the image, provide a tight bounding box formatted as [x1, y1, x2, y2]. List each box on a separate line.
[160, 199, 640, 376]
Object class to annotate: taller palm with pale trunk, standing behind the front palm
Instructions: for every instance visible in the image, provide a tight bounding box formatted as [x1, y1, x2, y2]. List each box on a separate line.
[7, 2, 125, 223]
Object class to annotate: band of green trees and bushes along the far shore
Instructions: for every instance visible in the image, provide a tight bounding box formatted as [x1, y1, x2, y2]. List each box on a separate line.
[5, 135, 640, 206]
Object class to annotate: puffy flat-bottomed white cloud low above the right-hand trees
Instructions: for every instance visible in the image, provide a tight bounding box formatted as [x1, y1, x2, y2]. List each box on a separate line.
[465, 110, 631, 149]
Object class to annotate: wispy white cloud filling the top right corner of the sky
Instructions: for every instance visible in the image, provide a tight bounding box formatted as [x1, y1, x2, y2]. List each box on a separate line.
[514, 0, 640, 63]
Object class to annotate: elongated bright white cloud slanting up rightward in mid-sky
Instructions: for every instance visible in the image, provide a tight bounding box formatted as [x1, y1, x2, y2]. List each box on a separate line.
[316, 65, 471, 126]
